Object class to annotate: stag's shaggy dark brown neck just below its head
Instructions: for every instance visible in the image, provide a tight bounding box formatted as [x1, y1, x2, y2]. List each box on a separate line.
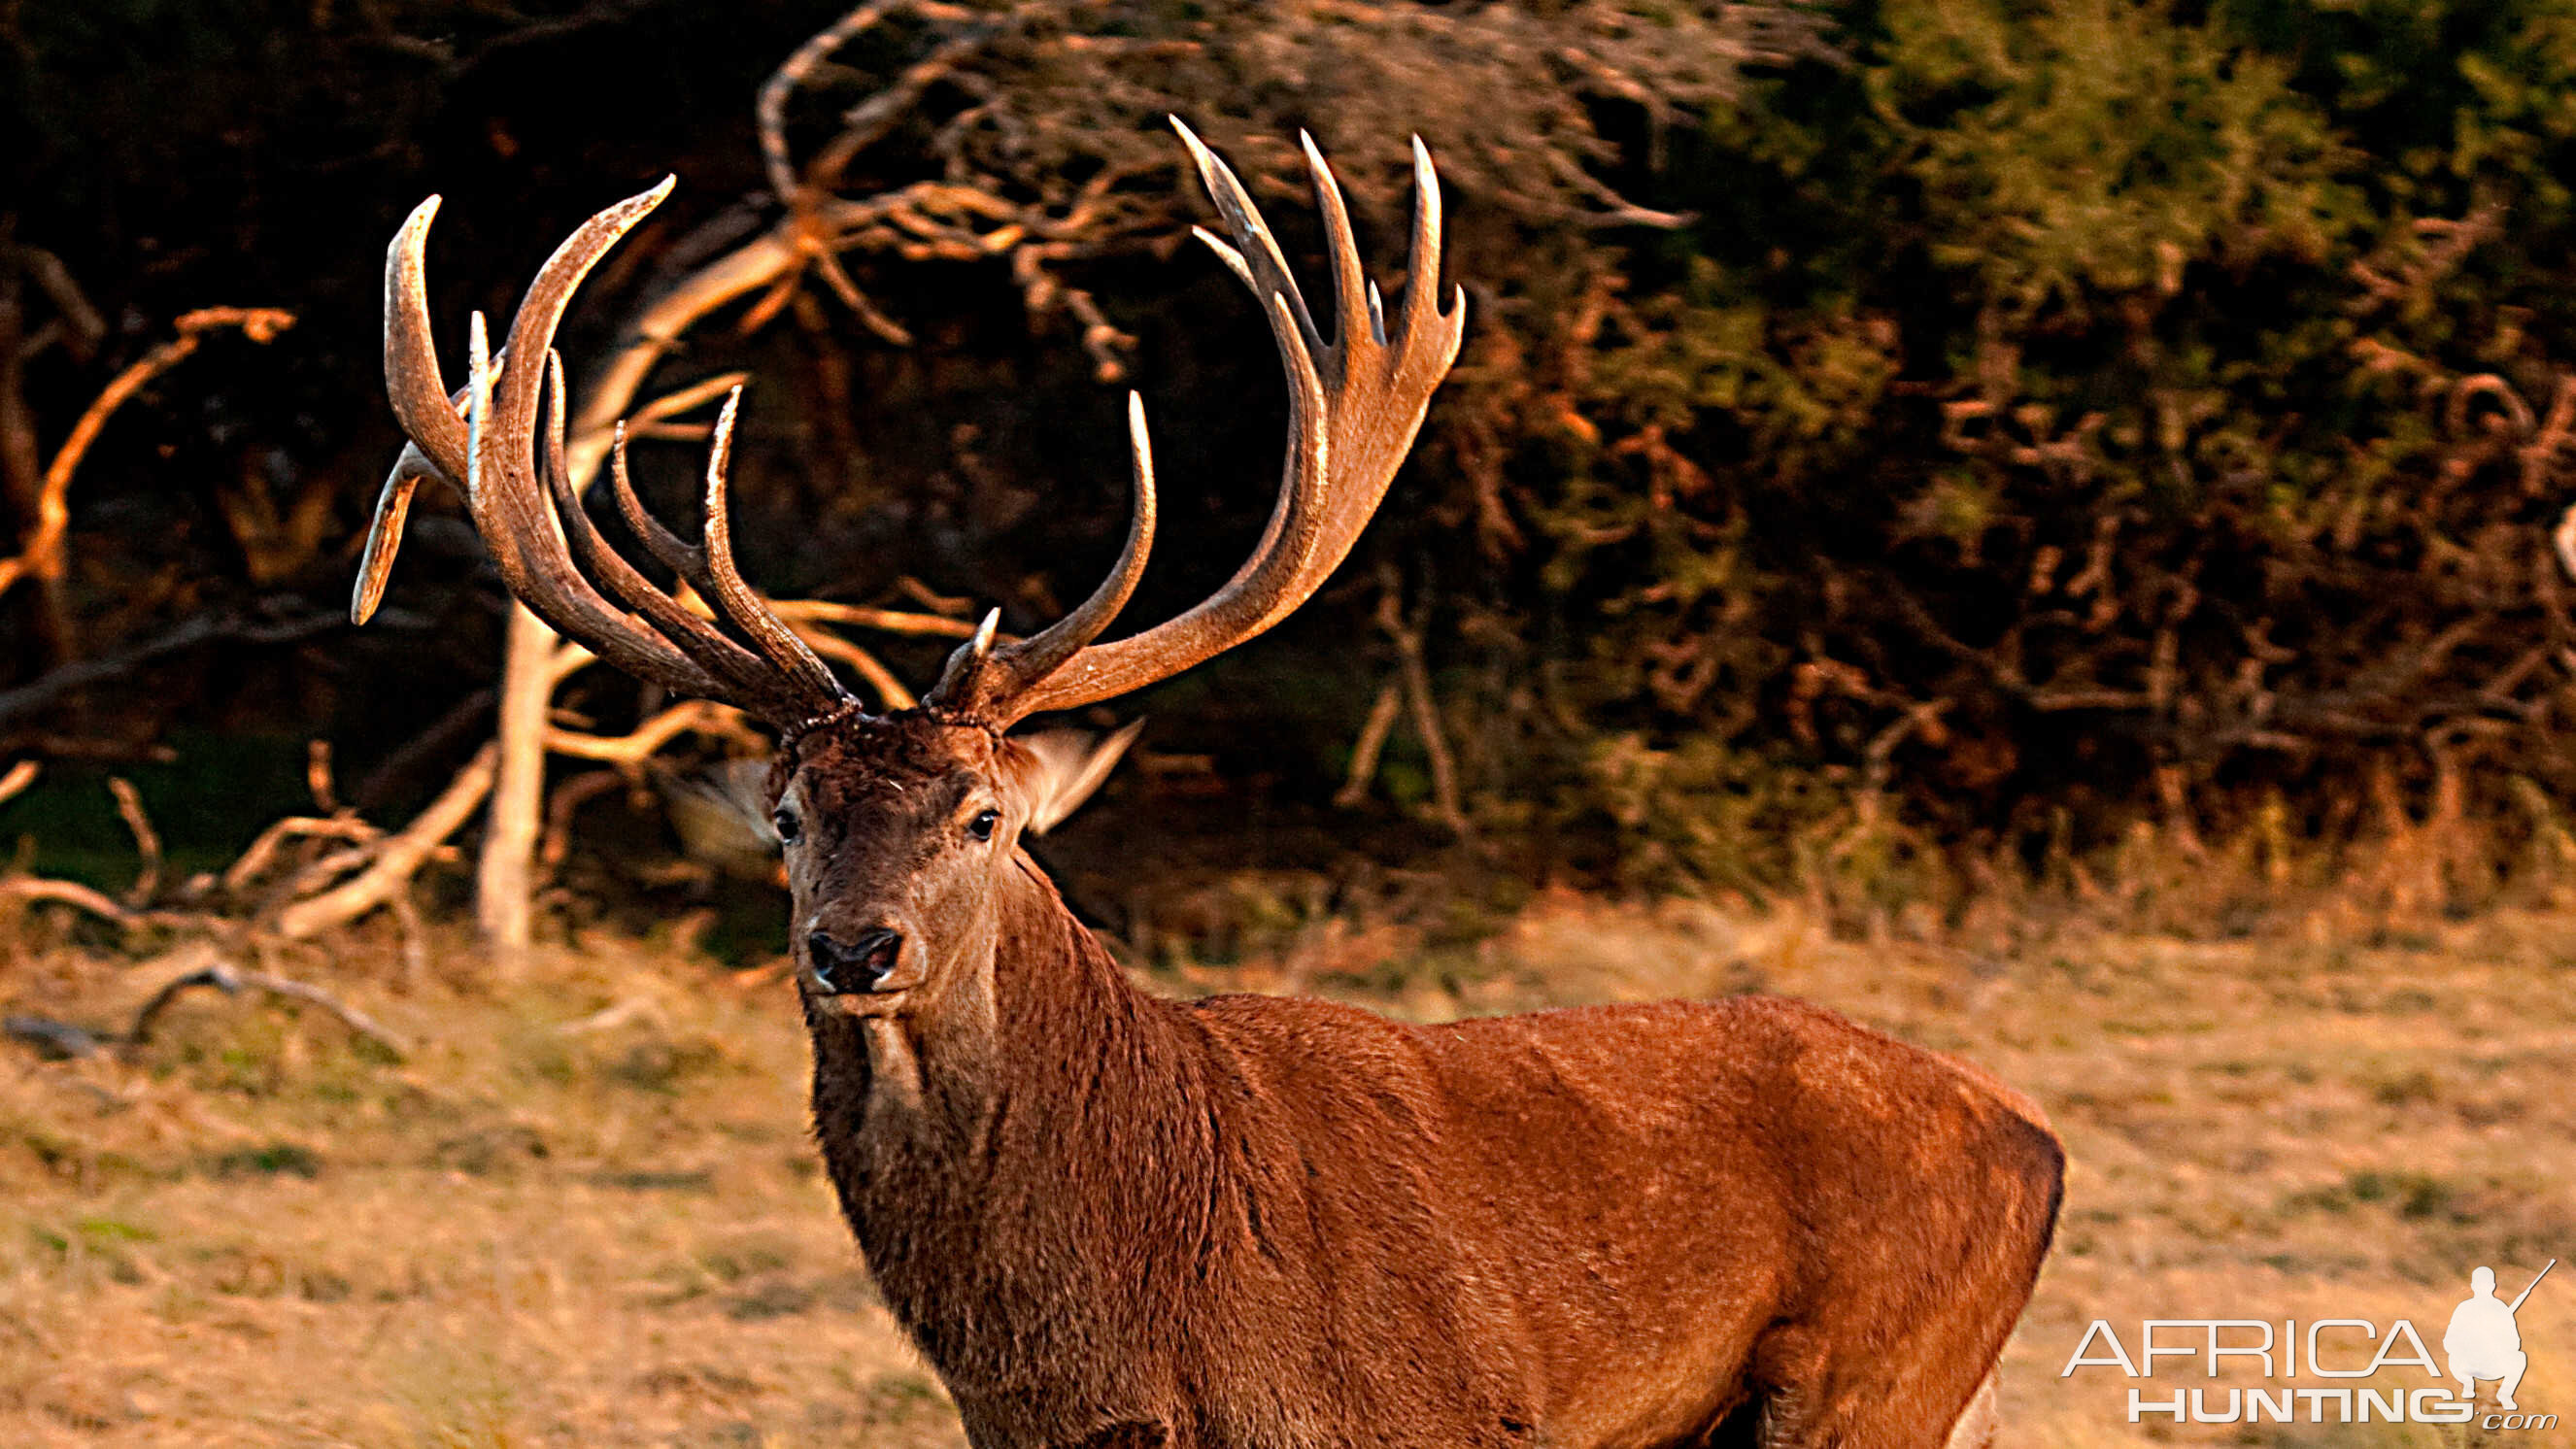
[814, 864, 1216, 1387]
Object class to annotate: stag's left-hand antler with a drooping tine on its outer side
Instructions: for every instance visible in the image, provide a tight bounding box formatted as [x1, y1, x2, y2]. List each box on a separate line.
[351, 181, 848, 725]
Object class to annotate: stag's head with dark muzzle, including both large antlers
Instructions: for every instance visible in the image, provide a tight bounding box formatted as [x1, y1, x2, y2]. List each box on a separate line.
[351, 121, 1466, 1017]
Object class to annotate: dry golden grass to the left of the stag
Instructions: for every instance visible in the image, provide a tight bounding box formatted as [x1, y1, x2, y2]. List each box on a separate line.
[0, 947, 956, 1449]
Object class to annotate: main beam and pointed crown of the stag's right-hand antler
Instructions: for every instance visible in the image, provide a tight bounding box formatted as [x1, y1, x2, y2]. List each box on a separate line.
[925, 118, 1466, 725]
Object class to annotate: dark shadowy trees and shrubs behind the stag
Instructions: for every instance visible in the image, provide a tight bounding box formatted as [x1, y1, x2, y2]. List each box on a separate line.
[15, 0, 2576, 922]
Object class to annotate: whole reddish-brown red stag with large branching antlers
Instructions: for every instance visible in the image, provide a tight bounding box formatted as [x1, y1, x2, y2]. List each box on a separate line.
[356, 129, 2063, 1449]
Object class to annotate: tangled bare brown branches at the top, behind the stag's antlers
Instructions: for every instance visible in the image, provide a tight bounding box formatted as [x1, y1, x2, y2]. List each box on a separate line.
[742, 0, 1826, 384]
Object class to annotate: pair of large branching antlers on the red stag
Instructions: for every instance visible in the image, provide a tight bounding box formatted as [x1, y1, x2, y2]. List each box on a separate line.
[351, 118, 1466, 728]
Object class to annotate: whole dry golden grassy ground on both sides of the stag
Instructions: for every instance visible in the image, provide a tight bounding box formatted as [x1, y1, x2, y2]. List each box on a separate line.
[0, 901, 2576, 1446]
